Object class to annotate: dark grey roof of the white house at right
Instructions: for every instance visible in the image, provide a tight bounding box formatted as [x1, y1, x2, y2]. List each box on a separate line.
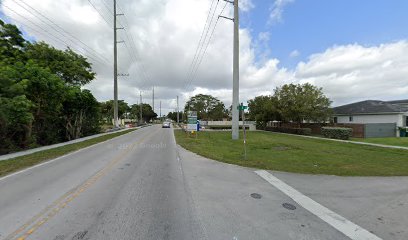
[333, 100, 408, 115]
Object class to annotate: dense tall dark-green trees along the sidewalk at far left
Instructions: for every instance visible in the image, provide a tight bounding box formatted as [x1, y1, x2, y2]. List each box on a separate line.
[0, 20, 101, 154]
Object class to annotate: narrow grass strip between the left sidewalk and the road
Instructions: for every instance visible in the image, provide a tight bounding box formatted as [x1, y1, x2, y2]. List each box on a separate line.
[0, 129, 135, 176]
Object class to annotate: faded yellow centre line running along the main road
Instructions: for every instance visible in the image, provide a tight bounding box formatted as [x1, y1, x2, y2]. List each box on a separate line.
[4, 126, 159, 240]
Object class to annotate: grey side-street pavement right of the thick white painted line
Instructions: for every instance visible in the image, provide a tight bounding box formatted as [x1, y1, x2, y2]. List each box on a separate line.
[269, 171, 408, 240]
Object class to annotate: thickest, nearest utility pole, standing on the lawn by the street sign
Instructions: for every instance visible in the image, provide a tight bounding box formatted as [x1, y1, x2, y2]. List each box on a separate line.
[232, 0, 239, 140]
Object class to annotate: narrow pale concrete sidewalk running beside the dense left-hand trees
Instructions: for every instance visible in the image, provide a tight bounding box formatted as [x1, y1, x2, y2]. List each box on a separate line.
[0, 127, 138, 161]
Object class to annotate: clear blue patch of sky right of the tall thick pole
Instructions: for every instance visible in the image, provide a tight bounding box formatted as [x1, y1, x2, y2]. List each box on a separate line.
[240, 0, 408, 68]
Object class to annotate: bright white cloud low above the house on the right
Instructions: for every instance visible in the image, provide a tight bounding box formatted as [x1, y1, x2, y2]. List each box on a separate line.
[295, 41, 408, 105]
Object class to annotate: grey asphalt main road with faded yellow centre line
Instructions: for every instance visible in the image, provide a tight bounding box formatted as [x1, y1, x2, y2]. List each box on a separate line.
[0, 126, 407, 240]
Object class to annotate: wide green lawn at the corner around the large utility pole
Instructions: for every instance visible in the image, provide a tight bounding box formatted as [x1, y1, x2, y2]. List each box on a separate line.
[175, 130, 408, 176]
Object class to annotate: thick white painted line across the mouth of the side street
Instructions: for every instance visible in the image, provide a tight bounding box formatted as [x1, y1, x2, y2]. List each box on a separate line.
[255, 170, 382, 240]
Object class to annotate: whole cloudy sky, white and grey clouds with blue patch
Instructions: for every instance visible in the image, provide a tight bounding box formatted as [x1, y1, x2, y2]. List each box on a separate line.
[0, 0, 408, 114]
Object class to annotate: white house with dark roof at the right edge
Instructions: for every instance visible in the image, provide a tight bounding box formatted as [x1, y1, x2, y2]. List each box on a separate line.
[333, 99, 408, 137]
